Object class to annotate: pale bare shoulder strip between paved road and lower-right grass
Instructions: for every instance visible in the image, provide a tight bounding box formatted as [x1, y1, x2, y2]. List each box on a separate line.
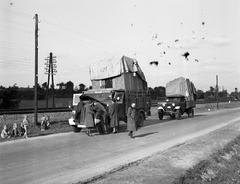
[85, 120, 240, 184]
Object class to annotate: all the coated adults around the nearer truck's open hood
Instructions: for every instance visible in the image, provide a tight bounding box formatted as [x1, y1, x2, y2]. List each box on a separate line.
[75, 98, 137, 138]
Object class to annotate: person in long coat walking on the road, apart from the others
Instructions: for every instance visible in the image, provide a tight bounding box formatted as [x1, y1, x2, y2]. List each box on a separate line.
[127, 103, 137, 139]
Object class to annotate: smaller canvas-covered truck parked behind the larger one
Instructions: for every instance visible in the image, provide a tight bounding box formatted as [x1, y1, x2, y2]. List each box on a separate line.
[158, 77, 196, 120]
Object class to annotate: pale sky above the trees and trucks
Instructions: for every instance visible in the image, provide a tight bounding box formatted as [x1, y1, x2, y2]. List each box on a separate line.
[0, 0, 240, 92]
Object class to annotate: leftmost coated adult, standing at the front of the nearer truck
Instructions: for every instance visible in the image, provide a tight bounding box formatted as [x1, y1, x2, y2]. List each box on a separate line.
[85, 101, 94, 137]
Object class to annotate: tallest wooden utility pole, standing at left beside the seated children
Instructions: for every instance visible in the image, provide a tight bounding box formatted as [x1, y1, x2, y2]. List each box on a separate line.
[34, 14, 38, 125]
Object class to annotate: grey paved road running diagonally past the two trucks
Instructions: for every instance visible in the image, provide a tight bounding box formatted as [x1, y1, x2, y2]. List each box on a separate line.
[0, 108, 240, 184]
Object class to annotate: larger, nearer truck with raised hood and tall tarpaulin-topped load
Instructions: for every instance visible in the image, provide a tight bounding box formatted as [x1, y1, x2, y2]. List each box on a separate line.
[69, 56, 151, 133]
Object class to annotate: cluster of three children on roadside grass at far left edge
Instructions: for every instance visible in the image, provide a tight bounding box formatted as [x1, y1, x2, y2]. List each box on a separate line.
[1, 115, 29, 139]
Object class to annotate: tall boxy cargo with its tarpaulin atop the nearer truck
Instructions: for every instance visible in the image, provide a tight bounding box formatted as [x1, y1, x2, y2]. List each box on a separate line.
[89, 56, 147, 91]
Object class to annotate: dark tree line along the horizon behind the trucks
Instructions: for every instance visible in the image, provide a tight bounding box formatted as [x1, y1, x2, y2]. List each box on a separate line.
[0, 81, 240, 109]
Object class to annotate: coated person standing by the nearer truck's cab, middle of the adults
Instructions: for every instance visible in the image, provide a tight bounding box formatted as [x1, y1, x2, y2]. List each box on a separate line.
[108, 99, 119, 133]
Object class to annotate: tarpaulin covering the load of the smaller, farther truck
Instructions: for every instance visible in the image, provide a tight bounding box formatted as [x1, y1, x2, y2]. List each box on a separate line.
[166, 77, 196, 97]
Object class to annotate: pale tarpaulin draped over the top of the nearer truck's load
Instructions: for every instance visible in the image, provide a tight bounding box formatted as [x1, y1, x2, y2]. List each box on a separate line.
[89, 56, 146, 81]
